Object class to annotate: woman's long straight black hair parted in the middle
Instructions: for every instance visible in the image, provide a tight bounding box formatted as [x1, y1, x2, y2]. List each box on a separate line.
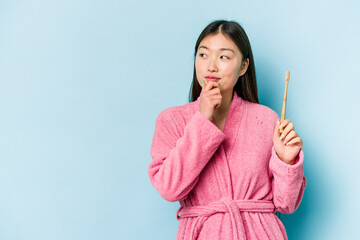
[189, 20, 259, 103]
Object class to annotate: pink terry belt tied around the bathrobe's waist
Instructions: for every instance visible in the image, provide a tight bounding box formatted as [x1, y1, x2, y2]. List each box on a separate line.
[176, 197, 275, 240]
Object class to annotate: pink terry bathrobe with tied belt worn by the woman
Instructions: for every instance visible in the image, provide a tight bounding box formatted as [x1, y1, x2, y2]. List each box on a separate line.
[148, 92, 306, 240]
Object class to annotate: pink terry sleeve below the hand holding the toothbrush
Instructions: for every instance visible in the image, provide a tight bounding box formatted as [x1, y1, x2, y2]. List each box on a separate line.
[269, 118, 306, 214]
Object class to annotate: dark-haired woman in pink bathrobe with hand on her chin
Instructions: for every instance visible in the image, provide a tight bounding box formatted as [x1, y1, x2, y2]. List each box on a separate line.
[148, 21, 306, 240]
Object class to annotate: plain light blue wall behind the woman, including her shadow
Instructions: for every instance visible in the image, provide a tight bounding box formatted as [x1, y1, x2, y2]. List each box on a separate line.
[0, 0, 360, 240]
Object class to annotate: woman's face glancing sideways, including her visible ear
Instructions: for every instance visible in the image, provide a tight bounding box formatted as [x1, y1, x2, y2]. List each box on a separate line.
[195, 33, 248, 92]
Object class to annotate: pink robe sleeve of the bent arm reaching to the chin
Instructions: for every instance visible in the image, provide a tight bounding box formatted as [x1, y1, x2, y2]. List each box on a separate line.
[148, 108, 226, 202]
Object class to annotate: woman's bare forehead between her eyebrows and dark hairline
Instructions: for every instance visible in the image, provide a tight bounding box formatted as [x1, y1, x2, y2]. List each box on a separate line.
[199, 33, 240, 53]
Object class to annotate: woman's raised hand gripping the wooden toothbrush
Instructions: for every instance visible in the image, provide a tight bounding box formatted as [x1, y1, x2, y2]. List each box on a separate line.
[273, 119, 303, 165]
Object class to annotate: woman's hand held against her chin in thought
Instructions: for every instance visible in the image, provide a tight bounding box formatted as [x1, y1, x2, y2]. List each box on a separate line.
[200, 81, 222, 121]
